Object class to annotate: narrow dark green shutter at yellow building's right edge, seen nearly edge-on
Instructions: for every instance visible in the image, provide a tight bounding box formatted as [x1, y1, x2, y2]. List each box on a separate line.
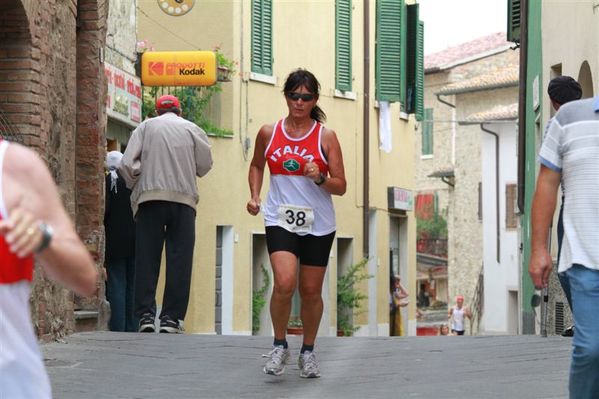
[405, 4, 424, 121]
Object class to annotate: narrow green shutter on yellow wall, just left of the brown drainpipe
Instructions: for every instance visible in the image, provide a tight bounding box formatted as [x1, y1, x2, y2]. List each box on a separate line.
[335, 0, 352, 91]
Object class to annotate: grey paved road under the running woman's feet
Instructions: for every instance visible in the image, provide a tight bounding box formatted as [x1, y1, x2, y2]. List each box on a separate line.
[42, 332, 571, 399]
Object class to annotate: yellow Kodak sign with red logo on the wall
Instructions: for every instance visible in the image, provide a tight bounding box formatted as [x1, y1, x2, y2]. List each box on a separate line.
[141, 51, 216, 86]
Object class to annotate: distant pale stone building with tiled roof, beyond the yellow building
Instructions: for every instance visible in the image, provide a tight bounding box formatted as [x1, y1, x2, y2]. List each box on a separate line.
[415, 33, 519, 333]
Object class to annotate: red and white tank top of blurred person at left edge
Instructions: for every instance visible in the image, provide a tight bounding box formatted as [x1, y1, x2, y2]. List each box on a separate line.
[0, 140, 51, 398]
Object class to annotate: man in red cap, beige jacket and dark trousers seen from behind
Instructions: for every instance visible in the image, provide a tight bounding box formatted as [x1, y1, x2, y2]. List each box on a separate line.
[119, 95, 212, 333]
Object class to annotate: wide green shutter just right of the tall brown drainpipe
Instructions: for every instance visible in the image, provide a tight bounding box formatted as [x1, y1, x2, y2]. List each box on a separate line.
[375, 0, 405, 102]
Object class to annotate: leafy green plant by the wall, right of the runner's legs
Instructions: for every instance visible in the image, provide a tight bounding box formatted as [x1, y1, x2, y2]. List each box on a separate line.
[337, 258, 374, 336]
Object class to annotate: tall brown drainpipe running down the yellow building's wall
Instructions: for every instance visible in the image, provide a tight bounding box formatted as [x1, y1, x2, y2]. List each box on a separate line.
[362, 0, 370, 258]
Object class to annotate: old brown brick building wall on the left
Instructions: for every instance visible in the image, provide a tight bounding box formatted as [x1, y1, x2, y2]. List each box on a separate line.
[0, 0, 108, 339]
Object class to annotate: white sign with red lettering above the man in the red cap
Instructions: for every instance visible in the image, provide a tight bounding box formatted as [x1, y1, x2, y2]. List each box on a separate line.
[104, 63, 142, 127]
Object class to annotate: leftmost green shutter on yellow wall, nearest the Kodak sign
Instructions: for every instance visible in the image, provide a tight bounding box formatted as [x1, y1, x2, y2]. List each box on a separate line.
[252, 0, 272, 75]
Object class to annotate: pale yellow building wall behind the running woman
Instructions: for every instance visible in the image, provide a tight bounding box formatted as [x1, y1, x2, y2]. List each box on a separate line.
[137, 0, 416, 333]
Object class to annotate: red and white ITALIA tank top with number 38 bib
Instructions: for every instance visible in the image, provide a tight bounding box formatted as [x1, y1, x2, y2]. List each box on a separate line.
[263, 119, 336, 236]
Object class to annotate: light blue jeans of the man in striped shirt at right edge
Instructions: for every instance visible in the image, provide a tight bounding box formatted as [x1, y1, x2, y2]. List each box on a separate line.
[566, 264, 599, 399]
